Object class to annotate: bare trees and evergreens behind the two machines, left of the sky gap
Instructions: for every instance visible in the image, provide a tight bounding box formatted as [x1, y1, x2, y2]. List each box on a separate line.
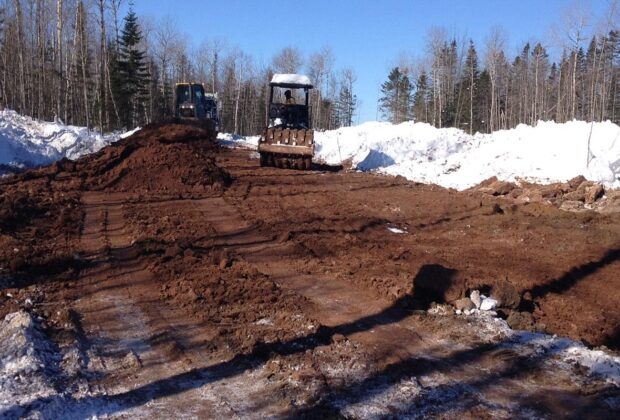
[0, 0, 359, 135]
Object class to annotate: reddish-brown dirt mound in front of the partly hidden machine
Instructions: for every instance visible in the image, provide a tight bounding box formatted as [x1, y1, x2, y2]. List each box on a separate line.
[74, 124, 231, 193]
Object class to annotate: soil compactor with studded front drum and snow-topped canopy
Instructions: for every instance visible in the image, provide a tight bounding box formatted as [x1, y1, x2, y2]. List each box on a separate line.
[258, 74, 314, 169]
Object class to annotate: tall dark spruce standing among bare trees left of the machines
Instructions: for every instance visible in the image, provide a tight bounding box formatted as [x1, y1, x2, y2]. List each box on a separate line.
[113, 6, 150, 127]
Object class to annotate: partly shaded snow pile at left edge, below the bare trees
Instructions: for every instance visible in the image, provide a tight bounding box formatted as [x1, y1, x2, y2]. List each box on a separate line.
[0, 110, 132, 172]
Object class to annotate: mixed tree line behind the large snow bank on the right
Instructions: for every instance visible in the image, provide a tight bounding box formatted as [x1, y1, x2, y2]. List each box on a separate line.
[379, 9, 620, 133]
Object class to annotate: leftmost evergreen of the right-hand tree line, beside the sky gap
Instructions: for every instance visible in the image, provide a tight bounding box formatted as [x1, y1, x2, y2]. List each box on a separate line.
[379, 67, 413, 124]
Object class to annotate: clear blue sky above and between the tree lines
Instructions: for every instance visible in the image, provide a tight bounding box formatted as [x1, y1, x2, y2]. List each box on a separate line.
[124, 0, 609, 122]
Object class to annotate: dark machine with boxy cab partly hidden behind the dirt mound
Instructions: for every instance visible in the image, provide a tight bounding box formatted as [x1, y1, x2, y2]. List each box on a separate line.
[174, 83, 219, 140]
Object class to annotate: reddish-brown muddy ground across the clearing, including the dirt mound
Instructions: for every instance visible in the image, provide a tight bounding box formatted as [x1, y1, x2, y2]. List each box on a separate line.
[0, 125, 620, 418]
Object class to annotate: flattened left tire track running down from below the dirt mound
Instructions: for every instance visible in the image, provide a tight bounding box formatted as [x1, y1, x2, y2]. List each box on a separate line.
[75, 193, 230, 418]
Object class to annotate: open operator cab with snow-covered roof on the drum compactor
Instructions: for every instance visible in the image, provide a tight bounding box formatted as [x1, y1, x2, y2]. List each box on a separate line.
[267, 74, 313, 128]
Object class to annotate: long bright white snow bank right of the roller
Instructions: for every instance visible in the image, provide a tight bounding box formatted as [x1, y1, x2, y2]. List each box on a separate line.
[315, 121, 620, 189]
